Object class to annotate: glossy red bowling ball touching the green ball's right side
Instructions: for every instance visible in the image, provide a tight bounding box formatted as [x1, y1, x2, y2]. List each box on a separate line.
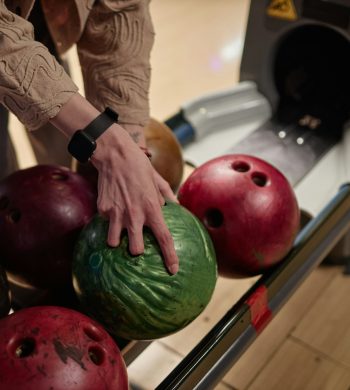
[178, 155, 300, 277]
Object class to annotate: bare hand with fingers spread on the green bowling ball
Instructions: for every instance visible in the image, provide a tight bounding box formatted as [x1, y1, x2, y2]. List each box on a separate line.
[91, 124, 179, 274]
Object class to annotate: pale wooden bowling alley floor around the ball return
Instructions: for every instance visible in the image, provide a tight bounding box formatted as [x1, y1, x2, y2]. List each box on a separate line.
[7, 0, 350, 390]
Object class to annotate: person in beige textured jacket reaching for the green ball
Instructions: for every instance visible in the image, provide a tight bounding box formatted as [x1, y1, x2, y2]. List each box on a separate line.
[0, 0, 179, 274]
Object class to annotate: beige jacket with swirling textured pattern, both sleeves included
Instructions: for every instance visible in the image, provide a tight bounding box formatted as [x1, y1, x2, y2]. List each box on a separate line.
[0, 0, 154, 130]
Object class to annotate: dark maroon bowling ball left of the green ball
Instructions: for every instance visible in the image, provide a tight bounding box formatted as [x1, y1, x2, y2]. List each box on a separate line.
[0, 165, 96, 289]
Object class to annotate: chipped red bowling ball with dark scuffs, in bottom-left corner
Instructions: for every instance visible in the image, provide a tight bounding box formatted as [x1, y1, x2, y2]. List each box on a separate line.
[0, 306, 128, 390]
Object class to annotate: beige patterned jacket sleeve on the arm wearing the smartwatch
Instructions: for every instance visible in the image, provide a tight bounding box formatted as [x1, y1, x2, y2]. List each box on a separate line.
[0, 0, 78, 130]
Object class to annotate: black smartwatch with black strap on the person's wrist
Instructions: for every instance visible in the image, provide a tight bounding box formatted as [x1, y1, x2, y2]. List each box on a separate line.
[68, 107, 118, 163]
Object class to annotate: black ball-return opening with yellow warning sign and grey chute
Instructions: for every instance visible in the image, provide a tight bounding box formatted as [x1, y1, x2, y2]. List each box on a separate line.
[230, 0, 350, 185]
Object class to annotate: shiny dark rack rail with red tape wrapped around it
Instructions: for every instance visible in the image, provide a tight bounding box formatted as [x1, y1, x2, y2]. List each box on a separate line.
[151, 184, 350, 390]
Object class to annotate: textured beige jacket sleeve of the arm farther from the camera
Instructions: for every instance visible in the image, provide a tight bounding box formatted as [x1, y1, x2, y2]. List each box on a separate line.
[77, 0, 154, 126]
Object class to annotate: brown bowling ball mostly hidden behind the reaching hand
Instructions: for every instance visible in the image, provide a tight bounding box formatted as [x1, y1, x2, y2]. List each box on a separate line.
[72, 118, 184, 192]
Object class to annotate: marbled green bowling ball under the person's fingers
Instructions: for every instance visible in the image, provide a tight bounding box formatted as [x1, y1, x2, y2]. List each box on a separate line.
[73, 202, 217, 340]
